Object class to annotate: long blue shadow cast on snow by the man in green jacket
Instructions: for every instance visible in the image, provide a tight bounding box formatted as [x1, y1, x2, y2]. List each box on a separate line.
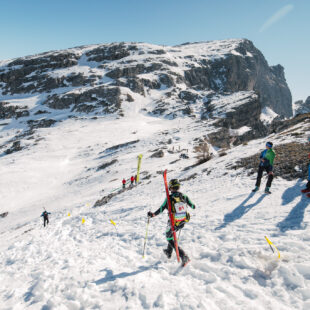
[215, 192, 266, 230]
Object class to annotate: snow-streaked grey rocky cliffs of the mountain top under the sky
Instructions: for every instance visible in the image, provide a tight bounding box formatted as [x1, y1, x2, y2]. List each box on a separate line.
[0, 40, 292, 154]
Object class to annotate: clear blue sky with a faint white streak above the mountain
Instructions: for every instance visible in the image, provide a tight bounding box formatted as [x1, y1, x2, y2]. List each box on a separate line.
[0, 0, 310, 101]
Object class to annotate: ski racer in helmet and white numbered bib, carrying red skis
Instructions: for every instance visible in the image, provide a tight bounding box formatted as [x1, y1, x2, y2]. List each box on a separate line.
[147, 179, 196, 267]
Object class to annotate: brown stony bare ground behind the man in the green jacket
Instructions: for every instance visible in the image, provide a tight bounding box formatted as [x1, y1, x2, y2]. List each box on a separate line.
[230, 142, 310, 180]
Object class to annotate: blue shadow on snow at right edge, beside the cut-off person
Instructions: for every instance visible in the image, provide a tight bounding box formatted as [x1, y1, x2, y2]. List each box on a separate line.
[277, 179, 310, 232]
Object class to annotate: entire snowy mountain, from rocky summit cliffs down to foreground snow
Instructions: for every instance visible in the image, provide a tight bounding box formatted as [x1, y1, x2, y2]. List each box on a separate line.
[0, 40, 310, 309]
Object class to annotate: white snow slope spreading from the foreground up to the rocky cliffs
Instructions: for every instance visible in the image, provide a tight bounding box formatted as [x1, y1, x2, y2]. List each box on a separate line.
[0, 103, 310, 310]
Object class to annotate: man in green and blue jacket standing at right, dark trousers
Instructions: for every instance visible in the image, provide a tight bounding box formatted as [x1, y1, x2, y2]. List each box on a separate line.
[253, 142, 276, 194]
